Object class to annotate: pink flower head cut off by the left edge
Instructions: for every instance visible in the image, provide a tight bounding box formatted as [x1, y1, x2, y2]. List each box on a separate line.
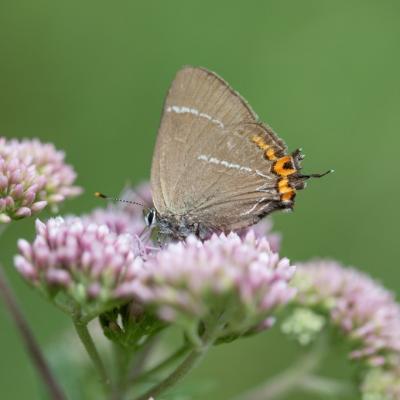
[0, 138, 81, 223]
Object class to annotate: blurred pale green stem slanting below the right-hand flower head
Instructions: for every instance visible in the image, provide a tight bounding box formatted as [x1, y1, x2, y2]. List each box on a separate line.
[236, 342, 326, 400]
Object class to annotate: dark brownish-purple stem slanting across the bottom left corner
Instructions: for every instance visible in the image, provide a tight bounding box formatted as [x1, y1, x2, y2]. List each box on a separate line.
[0, 264, 66, 400]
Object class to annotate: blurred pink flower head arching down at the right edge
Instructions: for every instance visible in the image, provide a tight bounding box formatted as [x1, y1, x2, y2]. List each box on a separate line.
[294, 261, 400, 367]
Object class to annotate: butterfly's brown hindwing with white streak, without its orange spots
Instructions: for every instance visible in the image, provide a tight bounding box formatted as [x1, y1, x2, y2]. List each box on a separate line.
[188, 123, 290, 231]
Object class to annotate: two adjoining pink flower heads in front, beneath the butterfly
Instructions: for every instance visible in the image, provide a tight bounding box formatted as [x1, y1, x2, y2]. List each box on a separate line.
[15, 207, 295, 338]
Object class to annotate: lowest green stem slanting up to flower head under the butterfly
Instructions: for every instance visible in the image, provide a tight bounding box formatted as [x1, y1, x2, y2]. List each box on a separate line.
[135, 347, 208, 400]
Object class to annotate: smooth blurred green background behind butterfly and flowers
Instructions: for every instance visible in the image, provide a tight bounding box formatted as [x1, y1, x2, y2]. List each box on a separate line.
[0, 0, 400, 400]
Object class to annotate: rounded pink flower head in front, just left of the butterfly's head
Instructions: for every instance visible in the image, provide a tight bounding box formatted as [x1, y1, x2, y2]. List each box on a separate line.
[15, 217, 141, 318]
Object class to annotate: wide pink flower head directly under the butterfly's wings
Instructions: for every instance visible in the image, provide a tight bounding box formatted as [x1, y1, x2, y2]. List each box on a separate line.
[126, 232, 295, 346]
